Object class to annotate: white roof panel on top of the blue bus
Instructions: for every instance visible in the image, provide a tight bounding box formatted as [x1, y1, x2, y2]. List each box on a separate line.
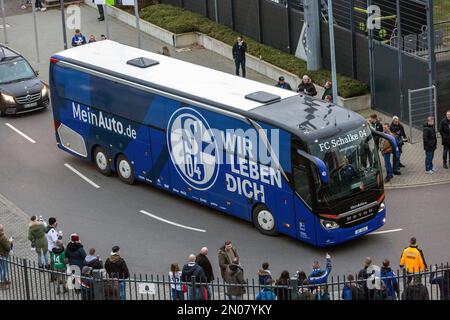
[57, 40, 296, 111]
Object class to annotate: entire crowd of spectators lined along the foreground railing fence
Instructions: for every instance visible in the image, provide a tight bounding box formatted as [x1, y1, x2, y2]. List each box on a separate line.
[0, 216, 450, 300]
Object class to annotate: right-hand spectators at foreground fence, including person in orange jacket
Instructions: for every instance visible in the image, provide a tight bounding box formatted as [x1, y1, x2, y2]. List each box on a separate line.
[169, 238, 450, 300]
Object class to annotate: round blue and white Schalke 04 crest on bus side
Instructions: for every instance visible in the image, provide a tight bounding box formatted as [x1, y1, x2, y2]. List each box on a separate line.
[167, 107, 219, 190]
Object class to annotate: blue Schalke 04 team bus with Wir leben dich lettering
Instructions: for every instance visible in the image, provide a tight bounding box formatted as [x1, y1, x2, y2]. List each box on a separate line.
[50, 40, 397, 246]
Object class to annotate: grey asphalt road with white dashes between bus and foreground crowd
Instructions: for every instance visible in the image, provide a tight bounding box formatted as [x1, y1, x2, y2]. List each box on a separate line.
[0, 104, 450, 277]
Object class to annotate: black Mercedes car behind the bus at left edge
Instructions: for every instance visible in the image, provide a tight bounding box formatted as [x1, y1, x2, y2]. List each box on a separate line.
[0, 44, 49, 116]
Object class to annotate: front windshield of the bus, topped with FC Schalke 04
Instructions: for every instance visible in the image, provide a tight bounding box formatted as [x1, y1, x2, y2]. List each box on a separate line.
[309, 126, 381, 208]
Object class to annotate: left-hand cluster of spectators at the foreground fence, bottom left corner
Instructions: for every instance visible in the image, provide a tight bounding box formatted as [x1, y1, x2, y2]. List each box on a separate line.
[0, 216, 130, 300]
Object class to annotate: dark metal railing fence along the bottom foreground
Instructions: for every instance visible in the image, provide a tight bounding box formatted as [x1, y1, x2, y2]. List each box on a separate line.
[0, 257, 450, 300]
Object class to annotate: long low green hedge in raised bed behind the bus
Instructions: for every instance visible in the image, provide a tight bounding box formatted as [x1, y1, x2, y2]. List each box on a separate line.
[140, 4, 369, 98]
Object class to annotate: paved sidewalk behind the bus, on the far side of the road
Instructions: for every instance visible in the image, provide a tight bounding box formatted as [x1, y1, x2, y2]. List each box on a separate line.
[0, 5, 450, 188]
